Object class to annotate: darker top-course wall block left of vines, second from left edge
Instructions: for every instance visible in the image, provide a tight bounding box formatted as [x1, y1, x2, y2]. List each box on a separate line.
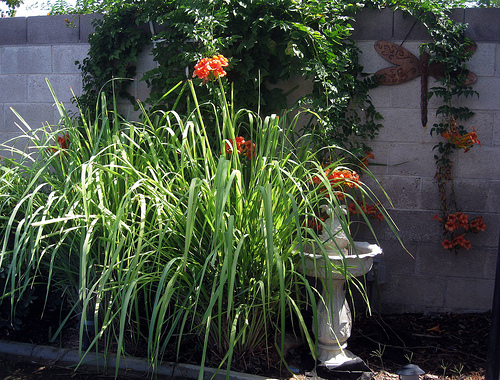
[27, 15, 80, 44]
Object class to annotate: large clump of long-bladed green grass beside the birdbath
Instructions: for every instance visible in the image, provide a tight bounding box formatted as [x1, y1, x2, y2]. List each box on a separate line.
[0, 79, 398, 379]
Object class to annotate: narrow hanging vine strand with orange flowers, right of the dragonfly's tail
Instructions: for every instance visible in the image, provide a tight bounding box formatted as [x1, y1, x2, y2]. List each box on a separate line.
[422, 20, 486, 253]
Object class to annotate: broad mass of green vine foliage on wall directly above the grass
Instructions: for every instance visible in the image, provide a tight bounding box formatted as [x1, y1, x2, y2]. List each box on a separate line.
[70, 0, 388, 160]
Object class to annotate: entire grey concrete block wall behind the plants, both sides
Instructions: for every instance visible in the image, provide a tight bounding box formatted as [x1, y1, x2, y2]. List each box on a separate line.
[0, 9, 500, 313]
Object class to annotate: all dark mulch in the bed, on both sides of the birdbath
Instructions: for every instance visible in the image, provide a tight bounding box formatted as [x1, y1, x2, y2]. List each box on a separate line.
[0, 313, 491, 380]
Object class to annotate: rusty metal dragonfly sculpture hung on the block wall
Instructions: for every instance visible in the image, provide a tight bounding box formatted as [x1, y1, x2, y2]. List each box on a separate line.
[375, 41, 477, 127]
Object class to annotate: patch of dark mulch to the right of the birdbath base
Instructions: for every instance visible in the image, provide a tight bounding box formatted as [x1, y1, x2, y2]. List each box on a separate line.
[349, 313, 491, 376]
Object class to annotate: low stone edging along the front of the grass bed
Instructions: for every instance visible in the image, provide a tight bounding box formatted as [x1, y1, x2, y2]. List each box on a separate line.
[0, 340, 276, 380]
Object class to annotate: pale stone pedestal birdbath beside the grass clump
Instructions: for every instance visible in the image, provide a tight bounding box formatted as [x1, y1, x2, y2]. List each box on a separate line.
[302, 208, 382, 369]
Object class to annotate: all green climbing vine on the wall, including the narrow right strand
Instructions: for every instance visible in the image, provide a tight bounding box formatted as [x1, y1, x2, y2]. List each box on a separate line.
[71, 0, 483, 250]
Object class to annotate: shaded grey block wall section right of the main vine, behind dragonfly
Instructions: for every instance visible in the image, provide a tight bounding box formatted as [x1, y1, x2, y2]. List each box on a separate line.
[355, 9, 500, 313]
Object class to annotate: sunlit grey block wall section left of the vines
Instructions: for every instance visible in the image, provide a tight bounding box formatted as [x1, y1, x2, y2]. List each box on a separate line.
[0, 15, 96, 147]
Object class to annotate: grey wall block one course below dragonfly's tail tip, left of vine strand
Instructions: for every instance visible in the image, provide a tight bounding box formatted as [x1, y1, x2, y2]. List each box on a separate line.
[387, 142, 435, 177]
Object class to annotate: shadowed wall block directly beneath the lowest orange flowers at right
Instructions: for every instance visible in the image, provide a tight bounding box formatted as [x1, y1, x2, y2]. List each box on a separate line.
[416, 242, 484, 279]
